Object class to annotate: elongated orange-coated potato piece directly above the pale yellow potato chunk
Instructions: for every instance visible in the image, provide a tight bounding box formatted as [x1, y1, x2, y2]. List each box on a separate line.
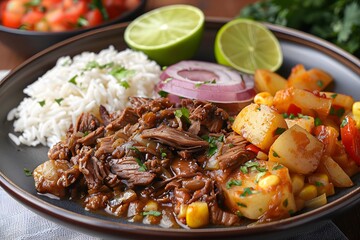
[273, 87, 332, 117]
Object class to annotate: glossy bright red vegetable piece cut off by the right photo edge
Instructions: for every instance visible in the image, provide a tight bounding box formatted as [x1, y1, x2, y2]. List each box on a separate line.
[340, 116, 360, 166]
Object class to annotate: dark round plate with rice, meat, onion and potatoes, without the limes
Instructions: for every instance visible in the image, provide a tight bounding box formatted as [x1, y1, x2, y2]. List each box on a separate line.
[0, 4, 360, 239]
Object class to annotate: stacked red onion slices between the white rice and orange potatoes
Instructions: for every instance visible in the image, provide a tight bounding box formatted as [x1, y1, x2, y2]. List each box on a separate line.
[155, 61, 256, 103]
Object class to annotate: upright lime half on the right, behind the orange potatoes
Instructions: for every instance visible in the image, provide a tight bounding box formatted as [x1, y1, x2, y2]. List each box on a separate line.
[214, 18, 283, 74]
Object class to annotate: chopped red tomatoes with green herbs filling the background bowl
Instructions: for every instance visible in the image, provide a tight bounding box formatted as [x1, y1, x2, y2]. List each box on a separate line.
[0, 0, 140, 32]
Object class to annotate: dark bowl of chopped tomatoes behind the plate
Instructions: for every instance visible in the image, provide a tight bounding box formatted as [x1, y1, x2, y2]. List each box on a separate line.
[0, 0, 146, 57]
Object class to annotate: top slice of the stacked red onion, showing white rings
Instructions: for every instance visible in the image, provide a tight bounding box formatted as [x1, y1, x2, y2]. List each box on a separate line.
[160, 61, 245, 91]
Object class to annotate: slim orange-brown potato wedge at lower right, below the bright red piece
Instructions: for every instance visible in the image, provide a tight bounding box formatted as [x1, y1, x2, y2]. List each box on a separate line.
[319, 155, 354, 187]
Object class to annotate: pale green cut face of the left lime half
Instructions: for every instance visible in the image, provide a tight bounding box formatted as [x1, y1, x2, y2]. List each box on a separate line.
[124, 4, 205, 51]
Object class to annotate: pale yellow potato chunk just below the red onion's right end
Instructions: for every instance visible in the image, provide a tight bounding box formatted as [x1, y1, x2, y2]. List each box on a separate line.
[232, 103, 287, 152]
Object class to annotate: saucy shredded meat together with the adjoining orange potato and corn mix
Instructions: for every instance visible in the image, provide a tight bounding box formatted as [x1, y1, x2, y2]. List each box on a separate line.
[33, 60, 360, 228]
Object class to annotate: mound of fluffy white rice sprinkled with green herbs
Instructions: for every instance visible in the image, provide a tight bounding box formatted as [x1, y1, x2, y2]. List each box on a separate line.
[7, 46, 161, 147]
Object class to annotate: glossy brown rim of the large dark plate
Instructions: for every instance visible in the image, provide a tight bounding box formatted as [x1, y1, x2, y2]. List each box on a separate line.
[0, 18, 360, 238]
